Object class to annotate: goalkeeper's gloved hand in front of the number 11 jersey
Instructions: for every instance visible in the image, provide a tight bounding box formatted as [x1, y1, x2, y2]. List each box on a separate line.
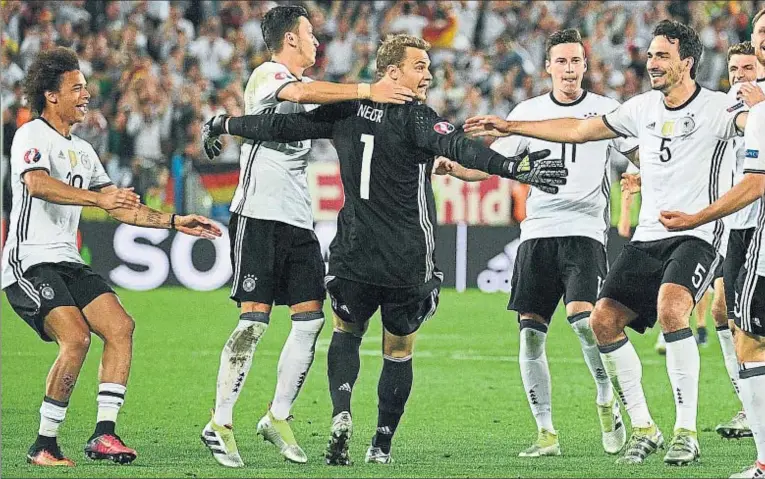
[501, 150, 568, 194]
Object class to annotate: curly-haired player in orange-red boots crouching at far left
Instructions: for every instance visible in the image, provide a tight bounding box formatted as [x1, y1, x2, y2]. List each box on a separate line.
[2, 47, 221, 466]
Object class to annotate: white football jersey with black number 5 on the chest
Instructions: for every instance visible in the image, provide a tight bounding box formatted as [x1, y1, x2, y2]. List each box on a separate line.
[603, 85, 742, 256]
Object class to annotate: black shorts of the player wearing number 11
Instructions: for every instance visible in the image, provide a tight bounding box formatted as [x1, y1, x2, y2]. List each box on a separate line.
[507, 236, 608, 321]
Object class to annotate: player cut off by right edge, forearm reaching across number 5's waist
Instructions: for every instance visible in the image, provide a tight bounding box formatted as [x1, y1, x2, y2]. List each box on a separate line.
[661, 9, 765, 478]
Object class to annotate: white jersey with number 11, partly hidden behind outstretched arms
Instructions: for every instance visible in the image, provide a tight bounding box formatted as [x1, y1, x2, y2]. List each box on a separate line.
[491, 91, 637, 245]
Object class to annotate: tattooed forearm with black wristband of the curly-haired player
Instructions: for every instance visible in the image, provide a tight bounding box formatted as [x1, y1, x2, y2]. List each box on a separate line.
[101, 185, 222, 239]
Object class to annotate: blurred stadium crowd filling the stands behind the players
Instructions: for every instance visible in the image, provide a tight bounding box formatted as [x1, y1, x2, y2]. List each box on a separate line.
[0, 0, 765, 216]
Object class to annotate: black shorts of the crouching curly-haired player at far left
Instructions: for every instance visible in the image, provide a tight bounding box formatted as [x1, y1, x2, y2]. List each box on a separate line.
[4, 262, 114, 341]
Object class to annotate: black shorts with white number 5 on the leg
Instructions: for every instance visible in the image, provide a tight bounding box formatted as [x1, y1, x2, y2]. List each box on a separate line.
[600, 236, 722, 333]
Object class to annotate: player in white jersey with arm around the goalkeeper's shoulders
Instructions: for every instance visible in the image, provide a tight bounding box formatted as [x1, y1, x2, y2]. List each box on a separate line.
[201, 6, 414, 467]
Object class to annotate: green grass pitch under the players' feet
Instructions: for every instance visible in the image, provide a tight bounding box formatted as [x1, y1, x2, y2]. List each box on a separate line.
[0, 289, 755, 478]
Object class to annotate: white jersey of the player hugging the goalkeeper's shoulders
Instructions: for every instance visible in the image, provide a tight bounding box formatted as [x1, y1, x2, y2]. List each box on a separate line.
[231, 62, 318, 229]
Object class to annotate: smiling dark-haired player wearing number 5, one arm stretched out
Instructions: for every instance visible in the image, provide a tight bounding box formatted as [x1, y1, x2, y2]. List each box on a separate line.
[465, 20, 747, 465]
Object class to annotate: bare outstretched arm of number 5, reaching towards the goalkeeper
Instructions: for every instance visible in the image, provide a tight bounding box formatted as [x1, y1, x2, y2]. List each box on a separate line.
[463, 115, 619, 143]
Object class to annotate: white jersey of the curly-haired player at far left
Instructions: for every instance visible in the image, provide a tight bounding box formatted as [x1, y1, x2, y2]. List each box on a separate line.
[3, 118, 112, 293]
